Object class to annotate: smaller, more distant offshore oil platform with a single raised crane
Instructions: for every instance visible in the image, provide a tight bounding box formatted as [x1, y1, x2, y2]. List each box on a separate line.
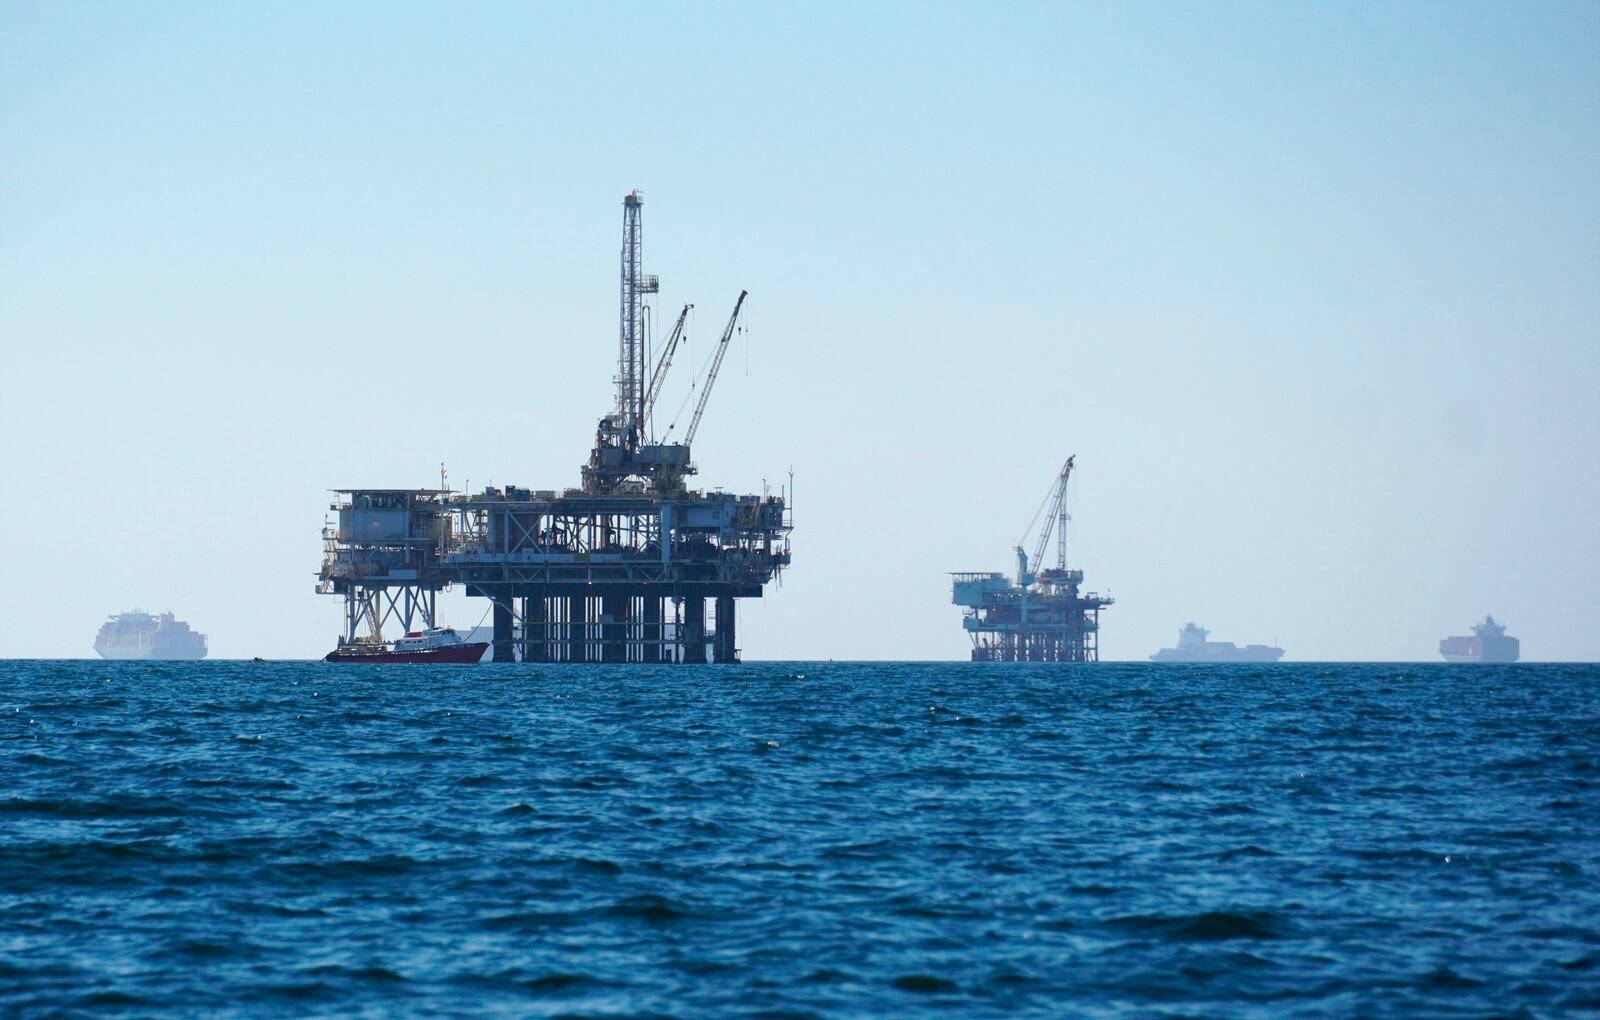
[950, 457, 1114, 662]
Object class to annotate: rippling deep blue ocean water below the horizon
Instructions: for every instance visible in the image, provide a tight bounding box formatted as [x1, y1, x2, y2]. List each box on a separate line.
[0, 662, 1600, 1017]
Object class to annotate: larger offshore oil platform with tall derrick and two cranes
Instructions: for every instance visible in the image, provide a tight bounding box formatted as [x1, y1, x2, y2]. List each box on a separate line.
[317, 190, 794, 663]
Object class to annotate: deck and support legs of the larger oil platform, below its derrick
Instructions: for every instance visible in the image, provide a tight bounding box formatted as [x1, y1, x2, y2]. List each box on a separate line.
[320, 486, 790, 663]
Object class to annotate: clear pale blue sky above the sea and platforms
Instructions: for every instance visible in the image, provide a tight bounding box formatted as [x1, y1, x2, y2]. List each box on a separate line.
[0, 0, 1600, 660]
